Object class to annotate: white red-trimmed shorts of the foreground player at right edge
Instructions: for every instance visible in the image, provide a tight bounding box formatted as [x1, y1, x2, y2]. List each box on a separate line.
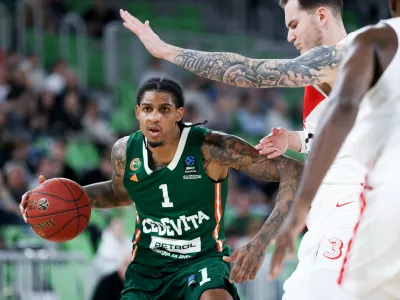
[341, 135, 400, 299]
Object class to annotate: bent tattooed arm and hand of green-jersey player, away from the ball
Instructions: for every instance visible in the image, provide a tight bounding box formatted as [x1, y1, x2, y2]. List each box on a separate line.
[202, 132, 303, 282]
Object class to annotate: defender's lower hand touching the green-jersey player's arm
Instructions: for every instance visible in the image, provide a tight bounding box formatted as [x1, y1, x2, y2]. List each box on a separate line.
[255, 127, 289, 159]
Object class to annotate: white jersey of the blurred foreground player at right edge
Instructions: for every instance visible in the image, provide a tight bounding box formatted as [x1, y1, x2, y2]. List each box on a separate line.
[349, 17, 400, 168]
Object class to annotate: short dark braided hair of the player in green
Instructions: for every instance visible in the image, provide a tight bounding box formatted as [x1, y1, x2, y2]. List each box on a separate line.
[136, 77, 185, 108]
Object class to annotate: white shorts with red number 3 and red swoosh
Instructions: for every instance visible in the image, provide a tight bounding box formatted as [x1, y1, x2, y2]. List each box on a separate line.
[282, 183, 362, 300]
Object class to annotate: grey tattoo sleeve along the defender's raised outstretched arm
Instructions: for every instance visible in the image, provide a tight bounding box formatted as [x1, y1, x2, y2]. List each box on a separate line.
[173, 46, 342, 88]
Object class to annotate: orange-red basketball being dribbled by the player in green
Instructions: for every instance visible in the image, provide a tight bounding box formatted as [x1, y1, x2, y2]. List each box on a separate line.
[26, 178, 91, 242]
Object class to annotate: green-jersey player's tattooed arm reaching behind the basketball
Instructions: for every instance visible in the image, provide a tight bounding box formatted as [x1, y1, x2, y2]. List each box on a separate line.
[83, 137, 132, 208]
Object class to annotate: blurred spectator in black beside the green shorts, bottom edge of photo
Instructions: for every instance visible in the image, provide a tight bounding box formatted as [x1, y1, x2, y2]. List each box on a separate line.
[92, 253, 132, 300]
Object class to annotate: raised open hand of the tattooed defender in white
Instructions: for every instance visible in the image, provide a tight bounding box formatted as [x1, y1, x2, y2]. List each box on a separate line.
[119, 9, 168, 58]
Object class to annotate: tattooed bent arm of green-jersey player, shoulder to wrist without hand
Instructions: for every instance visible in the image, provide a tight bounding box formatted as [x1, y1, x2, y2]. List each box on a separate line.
[202, 132, 303, 248]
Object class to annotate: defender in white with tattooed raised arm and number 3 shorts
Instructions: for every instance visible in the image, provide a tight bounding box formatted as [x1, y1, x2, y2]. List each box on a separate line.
[120, 0, 365, 300]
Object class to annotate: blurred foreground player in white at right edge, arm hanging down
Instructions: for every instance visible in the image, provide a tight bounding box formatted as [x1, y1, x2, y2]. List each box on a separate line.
[271, 0, 400, 300]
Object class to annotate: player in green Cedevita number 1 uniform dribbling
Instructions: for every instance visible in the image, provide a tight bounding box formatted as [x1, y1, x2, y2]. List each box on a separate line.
[22, 78, 302, 300]
